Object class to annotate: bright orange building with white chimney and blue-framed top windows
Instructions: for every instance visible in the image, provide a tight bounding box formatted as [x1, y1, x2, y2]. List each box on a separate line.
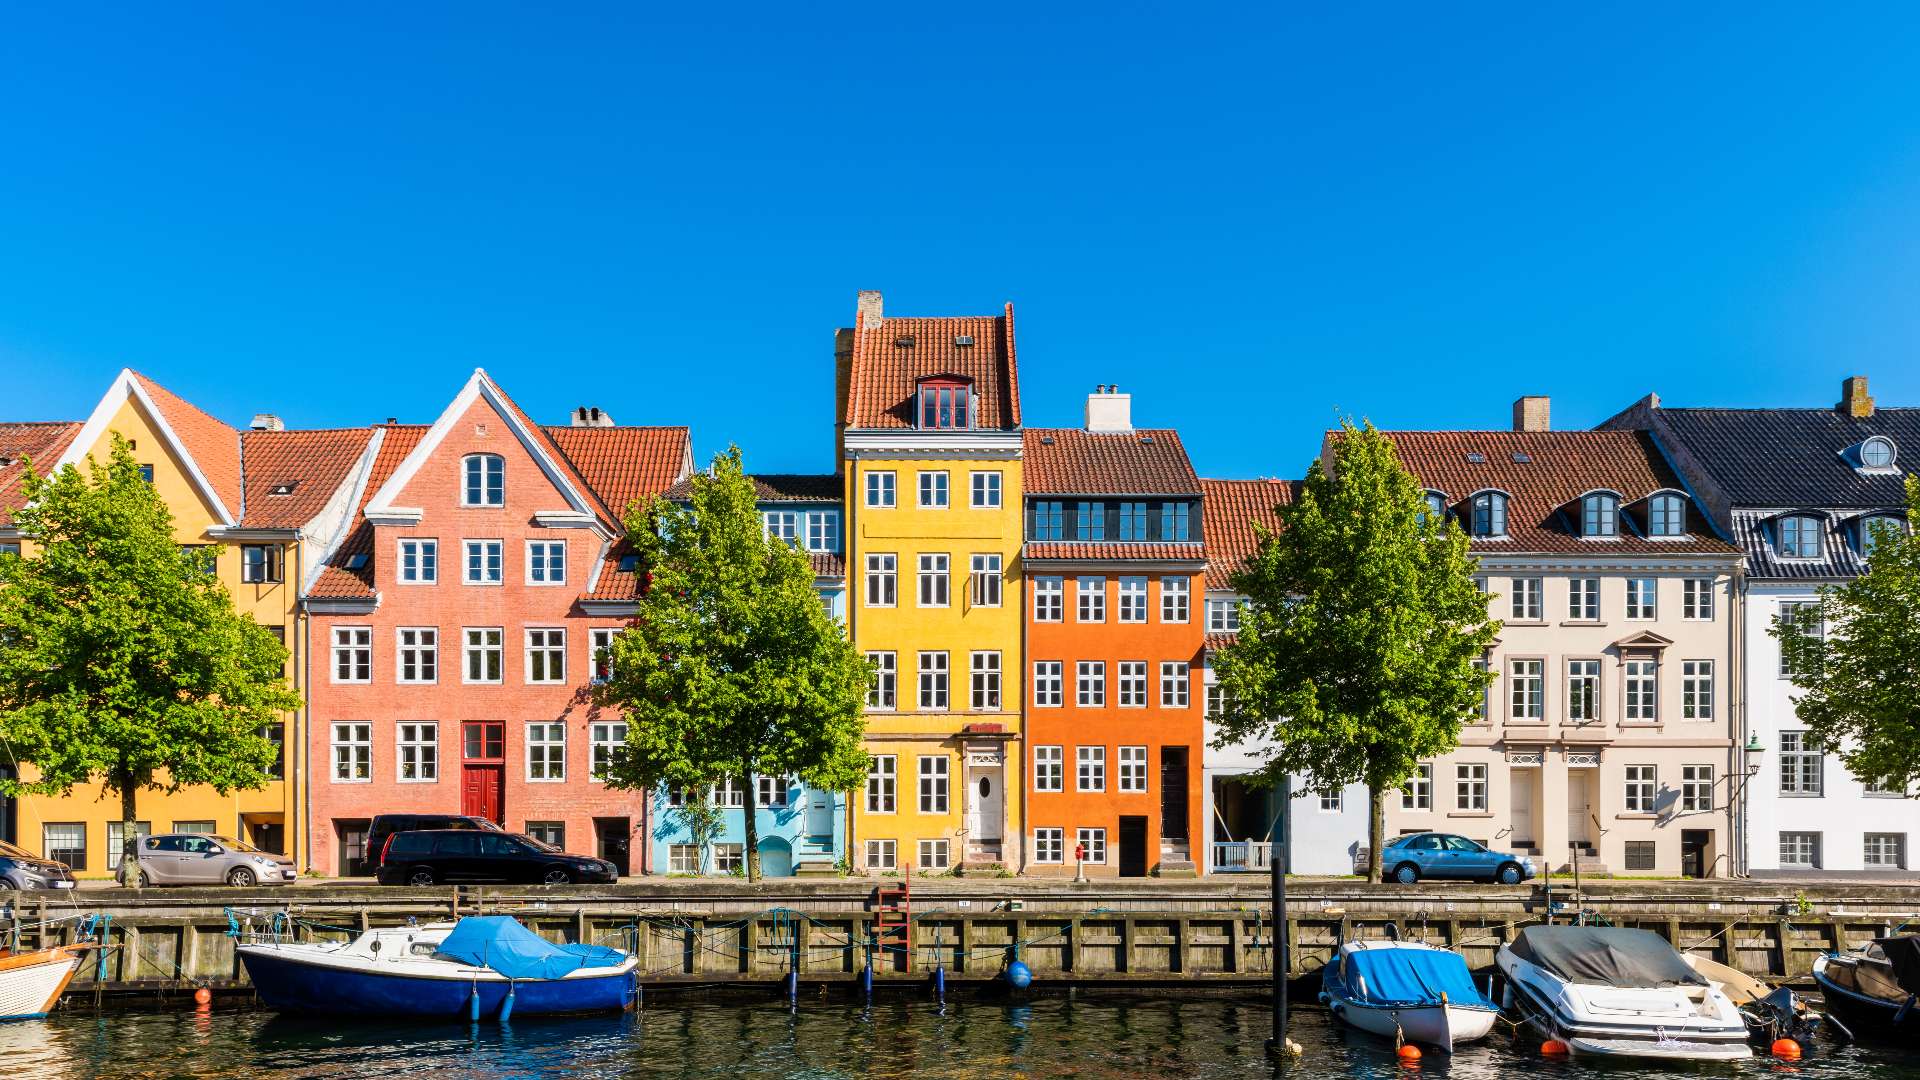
[1021, 388, 1206, 876]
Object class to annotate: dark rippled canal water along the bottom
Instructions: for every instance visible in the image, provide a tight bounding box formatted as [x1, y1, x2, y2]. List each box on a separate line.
[0, 995, 1920, 1080]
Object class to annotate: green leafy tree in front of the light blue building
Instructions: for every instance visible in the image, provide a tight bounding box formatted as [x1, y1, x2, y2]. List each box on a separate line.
[595, 448, 870, 880]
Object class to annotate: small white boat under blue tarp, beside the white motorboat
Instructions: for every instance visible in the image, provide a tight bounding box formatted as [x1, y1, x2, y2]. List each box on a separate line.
[1321, 942, 1500, 1053]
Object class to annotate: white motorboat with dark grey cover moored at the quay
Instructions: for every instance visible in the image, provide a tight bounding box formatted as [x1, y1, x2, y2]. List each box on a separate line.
[1496, 914, 1753, 1061]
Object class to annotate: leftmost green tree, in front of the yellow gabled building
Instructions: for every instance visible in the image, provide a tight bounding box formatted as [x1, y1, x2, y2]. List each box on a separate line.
[0, 436, 300, 884]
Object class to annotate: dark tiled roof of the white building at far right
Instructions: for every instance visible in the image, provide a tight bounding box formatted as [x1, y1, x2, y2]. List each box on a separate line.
[1659, 405, 1920, 509]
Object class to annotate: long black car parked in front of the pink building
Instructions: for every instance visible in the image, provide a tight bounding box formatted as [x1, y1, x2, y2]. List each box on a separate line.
[380, 828, 620, 886]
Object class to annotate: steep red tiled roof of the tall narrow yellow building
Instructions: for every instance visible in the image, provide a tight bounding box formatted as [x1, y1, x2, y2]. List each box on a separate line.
[845, 304, 1020, 430]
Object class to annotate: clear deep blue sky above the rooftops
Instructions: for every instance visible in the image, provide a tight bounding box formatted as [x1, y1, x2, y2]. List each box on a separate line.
[0, 4, 1920, 477]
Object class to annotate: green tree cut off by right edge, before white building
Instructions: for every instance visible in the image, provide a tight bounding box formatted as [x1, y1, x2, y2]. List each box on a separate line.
[1770, 477, 1920, 792]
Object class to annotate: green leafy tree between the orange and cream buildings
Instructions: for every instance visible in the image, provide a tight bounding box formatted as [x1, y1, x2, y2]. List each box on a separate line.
[1215, 421, 1500, 880]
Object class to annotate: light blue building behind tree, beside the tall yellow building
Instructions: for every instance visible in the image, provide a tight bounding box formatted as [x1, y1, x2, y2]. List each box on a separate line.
[649, 466, 847, 878]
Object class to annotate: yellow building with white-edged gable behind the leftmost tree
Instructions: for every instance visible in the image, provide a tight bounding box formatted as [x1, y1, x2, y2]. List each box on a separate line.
[0, 371, 372, 878]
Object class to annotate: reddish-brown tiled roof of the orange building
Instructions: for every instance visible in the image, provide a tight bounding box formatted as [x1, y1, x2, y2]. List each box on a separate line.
[1021, 427, 1200, 496]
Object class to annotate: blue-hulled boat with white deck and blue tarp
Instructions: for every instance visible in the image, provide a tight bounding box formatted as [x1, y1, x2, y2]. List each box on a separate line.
[238, 915, 639, 1020]
